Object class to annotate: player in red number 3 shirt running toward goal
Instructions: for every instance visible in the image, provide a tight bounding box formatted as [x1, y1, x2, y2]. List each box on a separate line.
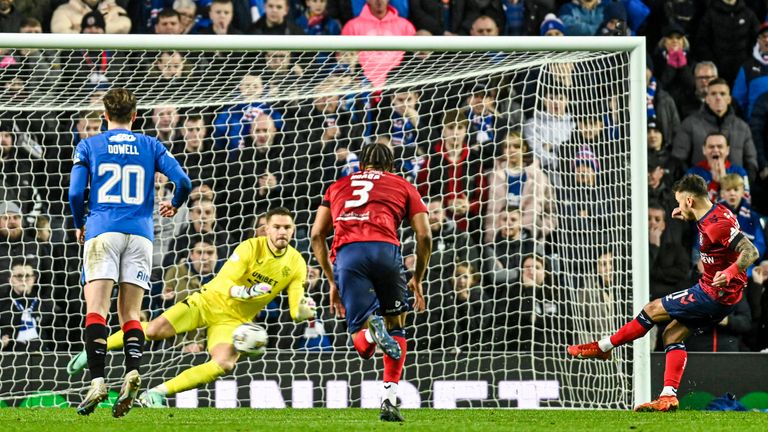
[312, 144, 432, 421]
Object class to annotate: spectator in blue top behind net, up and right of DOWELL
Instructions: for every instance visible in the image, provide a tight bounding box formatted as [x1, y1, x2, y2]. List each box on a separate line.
[213, 73, 283, 149]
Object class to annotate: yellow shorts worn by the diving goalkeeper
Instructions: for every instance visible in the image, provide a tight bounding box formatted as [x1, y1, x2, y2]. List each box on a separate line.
[162, 293, 242, 352]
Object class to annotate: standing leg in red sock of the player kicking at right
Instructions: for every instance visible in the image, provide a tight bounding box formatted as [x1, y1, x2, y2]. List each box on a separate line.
[635, 320, 691, 412]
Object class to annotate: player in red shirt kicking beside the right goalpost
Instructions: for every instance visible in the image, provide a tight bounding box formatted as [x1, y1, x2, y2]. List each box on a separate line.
[568, 175, 759, 411]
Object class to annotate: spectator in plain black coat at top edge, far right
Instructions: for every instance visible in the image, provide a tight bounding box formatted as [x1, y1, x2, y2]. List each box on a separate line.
[693, 0, 760, 83]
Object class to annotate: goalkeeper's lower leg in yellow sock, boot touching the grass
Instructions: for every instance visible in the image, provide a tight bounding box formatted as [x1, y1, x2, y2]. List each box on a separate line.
[139, 321, 241, 407]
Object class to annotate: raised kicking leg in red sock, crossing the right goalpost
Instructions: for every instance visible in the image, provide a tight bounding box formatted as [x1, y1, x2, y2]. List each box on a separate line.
[568, 299, 671, 360]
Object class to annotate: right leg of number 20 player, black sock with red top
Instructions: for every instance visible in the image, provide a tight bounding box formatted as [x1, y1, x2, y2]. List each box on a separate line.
[112, 282, 145, 417]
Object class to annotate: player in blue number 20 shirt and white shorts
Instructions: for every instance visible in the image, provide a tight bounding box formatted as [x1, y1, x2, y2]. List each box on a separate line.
[69, 88, 192, 417]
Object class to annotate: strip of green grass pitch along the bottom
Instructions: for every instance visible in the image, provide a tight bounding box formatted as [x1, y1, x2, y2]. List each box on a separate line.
[0, 408, 768, 432]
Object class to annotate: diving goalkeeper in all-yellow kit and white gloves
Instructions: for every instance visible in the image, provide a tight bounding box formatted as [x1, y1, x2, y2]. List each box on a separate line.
[67, 207, 315, 407]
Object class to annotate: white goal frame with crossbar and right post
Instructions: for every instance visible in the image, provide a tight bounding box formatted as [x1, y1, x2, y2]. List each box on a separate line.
[0, 33, 651, 403]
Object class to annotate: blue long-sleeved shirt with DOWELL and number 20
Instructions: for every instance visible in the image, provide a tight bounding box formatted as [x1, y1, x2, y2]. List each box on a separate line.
[70, 129, 191, 241]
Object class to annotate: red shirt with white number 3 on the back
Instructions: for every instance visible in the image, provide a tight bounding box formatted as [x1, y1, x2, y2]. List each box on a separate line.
[321, 170, 427, 261]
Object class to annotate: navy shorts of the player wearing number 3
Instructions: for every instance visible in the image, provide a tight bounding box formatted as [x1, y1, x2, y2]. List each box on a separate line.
[333, 242, 410, 333]
